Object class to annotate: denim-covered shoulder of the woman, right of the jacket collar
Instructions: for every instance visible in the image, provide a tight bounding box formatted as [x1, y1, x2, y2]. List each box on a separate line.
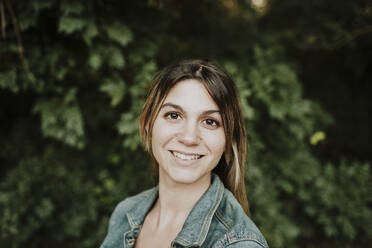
[209, 188, 268, 248]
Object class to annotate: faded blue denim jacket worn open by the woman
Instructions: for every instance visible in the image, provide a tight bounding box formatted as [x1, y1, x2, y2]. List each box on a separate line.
[101, 174, 268, 248]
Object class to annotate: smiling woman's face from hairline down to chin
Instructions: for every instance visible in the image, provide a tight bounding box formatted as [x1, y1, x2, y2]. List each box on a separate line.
[151, 79, 225, 184]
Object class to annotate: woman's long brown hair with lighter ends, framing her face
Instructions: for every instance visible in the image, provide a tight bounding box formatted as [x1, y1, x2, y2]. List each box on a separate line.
[139, 60, 249, 214]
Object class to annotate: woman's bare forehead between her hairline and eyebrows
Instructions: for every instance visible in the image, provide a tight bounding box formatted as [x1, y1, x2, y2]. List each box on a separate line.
[164, 79, 219, 111]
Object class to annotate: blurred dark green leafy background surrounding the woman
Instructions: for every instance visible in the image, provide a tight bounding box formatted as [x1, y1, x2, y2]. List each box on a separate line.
[0, 0, 372, 247]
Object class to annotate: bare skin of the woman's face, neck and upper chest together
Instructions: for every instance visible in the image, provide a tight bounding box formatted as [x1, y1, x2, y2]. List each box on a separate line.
[135, 79, 226, 248]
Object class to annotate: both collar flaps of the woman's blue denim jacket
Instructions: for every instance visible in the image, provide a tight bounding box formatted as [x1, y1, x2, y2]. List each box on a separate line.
[127, 174, 224, 247]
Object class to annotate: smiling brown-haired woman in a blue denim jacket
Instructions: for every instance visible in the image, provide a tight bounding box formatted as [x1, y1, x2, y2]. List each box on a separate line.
[101, 60, 268, 248]
